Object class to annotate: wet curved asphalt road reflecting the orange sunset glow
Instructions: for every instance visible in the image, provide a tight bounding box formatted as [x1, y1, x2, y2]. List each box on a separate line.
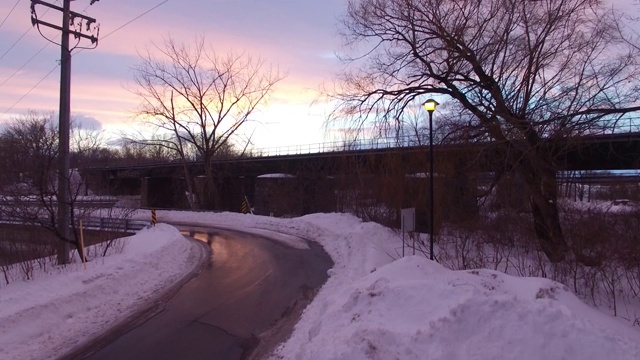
[77, 226, 333, 360]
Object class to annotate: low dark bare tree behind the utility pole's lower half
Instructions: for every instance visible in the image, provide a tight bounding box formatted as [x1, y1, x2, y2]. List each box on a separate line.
[0, 112, 130, 261]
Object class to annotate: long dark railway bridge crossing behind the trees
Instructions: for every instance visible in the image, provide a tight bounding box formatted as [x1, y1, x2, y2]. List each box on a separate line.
[81, 132, 640, 224]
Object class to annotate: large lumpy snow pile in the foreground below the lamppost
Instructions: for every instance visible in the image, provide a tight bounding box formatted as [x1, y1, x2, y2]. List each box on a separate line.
[279, 256, 640, 360]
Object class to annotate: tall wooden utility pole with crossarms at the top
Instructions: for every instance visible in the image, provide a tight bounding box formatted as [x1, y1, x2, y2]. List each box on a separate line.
[31, 0, 98, 264]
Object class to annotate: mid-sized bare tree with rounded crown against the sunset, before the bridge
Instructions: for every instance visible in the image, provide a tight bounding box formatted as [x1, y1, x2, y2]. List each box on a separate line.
[134, 37, 283, 207]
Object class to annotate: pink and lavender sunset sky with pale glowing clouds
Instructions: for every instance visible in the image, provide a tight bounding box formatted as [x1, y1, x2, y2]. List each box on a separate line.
[0, 0, 640, 148]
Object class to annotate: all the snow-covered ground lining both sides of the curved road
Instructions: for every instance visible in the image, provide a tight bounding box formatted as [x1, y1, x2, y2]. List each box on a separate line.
[0, 212, 640, 360]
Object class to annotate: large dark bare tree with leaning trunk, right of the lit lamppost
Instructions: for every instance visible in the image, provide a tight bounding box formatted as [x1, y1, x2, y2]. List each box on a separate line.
[334, 0, 640, 262]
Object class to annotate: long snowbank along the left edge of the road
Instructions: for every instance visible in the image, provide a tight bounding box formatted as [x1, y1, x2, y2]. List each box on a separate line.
[0, 225, 195, 360]
